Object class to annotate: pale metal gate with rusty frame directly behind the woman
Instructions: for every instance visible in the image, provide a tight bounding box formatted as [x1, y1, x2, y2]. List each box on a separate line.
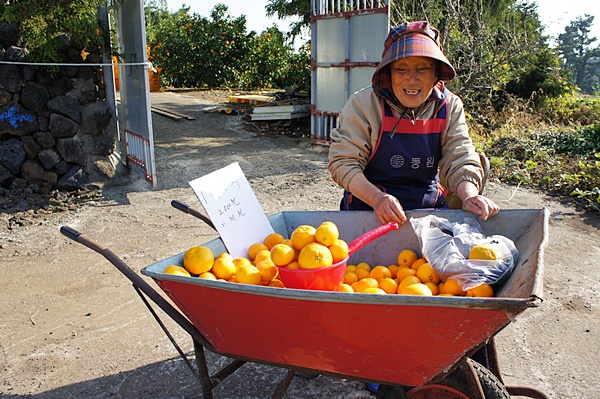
[311, 0, 389, 145]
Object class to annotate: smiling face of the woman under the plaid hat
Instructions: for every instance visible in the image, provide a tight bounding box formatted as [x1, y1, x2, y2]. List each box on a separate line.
[390, 57, 438, 108]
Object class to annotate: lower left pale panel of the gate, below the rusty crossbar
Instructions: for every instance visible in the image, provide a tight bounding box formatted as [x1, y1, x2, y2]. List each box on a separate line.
[315, 68, 347, 112]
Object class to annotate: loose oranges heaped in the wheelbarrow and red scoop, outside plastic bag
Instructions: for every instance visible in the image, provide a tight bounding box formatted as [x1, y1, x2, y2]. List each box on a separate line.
[164, 239, 494, 297]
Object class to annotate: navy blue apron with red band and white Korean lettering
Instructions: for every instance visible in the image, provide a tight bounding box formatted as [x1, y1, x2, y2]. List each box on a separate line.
[340, 94, 448, 210]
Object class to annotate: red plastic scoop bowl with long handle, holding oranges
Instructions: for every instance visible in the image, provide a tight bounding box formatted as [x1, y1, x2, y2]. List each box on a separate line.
[277, 223, 398, 291]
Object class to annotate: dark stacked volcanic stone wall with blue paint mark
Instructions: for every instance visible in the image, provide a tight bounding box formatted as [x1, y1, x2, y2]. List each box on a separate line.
[0, 24, 118, 195]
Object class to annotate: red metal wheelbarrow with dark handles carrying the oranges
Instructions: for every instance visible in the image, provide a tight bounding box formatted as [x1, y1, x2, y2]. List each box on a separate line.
[61, 201, 548, 399]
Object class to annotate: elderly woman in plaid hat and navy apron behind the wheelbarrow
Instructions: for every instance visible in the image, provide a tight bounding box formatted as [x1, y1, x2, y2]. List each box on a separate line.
[329, 21, 499, 224]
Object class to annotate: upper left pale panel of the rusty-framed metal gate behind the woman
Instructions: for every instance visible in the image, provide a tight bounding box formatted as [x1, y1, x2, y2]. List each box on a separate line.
[316, 18, 348, 63]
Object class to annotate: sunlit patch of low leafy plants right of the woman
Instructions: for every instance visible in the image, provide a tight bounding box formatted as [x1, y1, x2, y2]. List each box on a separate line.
[471, 98, 600, 212]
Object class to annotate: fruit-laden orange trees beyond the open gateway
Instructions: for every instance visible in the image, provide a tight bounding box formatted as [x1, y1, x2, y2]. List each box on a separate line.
[146, 4, 310, 89]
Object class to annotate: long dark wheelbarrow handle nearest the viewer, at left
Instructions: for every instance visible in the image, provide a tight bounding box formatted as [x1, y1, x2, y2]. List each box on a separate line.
[60, 226, 212, 348]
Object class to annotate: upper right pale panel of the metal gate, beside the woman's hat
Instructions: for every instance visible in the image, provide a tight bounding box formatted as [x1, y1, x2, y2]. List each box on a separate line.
[350, 14, 389, 62]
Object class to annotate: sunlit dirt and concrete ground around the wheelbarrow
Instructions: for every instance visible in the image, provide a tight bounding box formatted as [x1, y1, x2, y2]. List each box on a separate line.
[0, 92, 600, 399]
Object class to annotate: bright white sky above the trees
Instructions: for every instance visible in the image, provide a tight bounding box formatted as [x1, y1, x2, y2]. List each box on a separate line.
[167, 0, 600, 46]
